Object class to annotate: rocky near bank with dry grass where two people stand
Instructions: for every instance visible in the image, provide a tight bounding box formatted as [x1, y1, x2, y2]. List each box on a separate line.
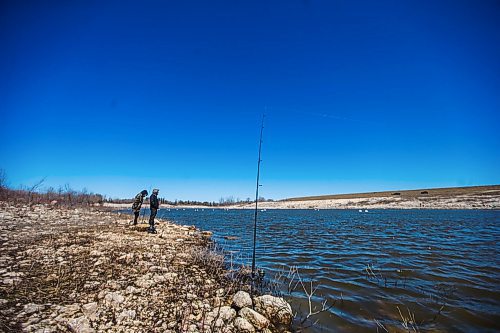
[0, 202, 292, 332]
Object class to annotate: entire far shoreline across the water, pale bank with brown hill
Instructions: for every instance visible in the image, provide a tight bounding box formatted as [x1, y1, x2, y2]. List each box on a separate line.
[104, 185, 500, 210]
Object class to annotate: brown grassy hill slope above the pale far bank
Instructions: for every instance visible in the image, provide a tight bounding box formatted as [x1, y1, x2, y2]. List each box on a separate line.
[283, 185, 500, 201]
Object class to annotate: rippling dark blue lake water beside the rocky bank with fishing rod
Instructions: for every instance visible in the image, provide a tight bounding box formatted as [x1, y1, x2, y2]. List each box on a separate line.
[153, 209, 500, 332]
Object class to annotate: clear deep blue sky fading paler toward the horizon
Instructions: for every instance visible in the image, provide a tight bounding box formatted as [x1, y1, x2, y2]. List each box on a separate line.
[0, 0, 500, 201]
